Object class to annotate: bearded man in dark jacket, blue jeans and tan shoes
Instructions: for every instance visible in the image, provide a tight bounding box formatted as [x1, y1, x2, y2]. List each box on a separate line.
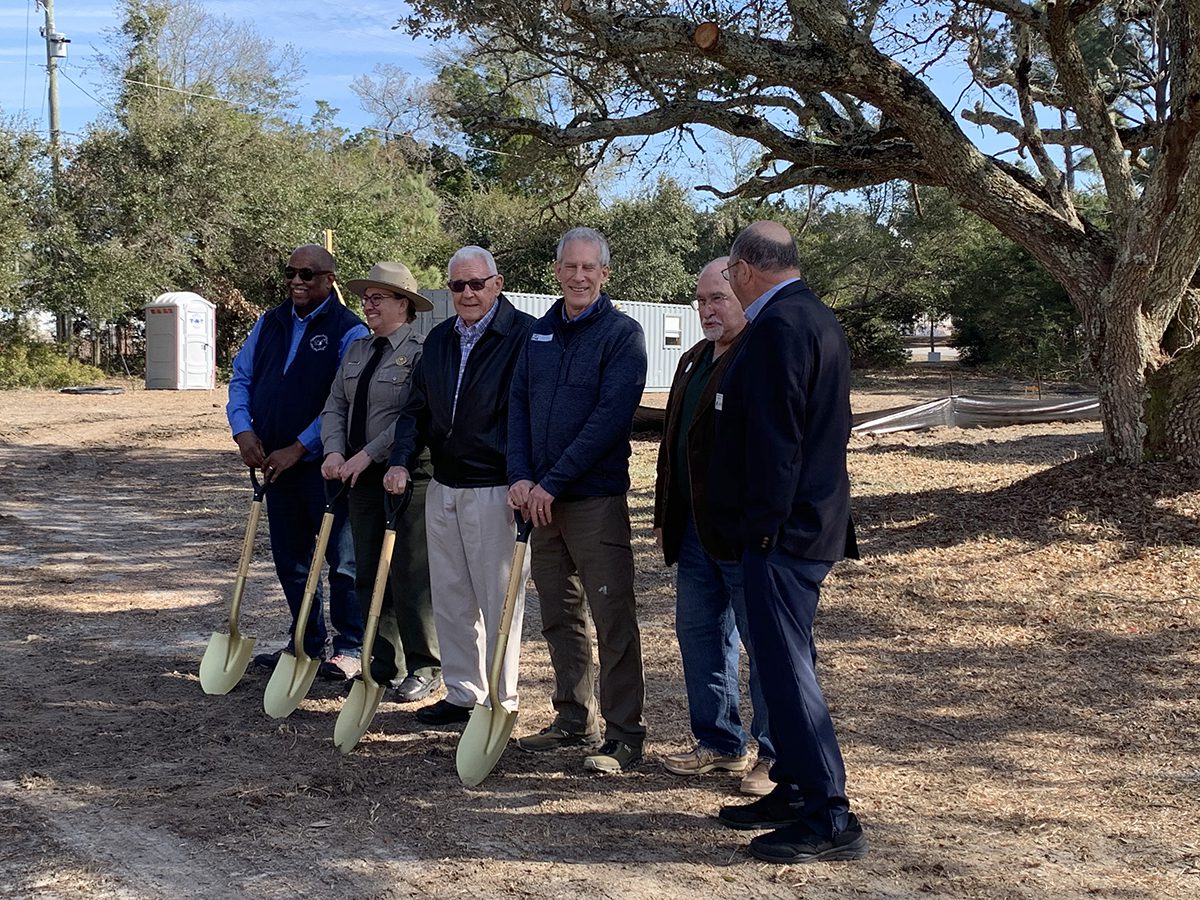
[654, 257, 775, 796]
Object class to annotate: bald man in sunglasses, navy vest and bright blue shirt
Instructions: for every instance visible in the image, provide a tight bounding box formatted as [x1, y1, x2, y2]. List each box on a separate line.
[226, 244, 368, 670]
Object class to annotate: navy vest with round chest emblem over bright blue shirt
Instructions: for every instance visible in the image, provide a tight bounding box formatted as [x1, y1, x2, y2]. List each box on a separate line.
[250, 300, 362, 454]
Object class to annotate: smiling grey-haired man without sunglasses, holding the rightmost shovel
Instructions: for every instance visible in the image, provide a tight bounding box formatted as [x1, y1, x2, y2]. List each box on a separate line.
[508, 228, 646, 773]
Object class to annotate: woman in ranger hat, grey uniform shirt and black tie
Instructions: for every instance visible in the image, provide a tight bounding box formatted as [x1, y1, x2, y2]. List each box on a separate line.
[320, 263, 442, 702]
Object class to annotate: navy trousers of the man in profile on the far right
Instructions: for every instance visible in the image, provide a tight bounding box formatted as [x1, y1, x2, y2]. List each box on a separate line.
[742, 548, 850, 836]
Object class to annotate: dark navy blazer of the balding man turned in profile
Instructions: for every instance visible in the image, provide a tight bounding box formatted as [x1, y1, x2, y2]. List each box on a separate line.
[708, 281, 857, 562]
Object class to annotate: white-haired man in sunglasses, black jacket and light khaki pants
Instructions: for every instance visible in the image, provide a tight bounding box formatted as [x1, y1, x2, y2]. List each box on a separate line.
[384, 247, 533, 726]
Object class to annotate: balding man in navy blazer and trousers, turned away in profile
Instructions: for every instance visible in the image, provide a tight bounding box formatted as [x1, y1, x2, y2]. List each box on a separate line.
[708, 222, 868, 863]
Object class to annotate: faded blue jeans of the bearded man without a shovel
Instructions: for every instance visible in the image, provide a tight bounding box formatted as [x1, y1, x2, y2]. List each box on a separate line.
[676, 517, 775, 760]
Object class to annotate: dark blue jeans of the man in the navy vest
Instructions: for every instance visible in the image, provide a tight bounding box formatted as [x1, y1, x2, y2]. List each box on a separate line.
[266, 462, 364, 659]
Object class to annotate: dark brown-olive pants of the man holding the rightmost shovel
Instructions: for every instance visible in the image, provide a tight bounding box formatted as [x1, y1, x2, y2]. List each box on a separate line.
[530, 494, 646, 748]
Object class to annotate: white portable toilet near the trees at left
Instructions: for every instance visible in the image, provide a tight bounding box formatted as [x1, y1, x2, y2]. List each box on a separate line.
[145, 290, 217, 390]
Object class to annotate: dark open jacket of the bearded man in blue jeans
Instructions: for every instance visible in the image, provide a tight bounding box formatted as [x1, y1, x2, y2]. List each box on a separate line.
[654, 331, 745, 565]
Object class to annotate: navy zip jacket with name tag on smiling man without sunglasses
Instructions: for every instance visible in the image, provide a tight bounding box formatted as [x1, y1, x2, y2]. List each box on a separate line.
[509, 294, 646, 500]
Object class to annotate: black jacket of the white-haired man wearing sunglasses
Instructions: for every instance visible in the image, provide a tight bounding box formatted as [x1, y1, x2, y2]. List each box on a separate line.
[391, 294, 533, 487]
